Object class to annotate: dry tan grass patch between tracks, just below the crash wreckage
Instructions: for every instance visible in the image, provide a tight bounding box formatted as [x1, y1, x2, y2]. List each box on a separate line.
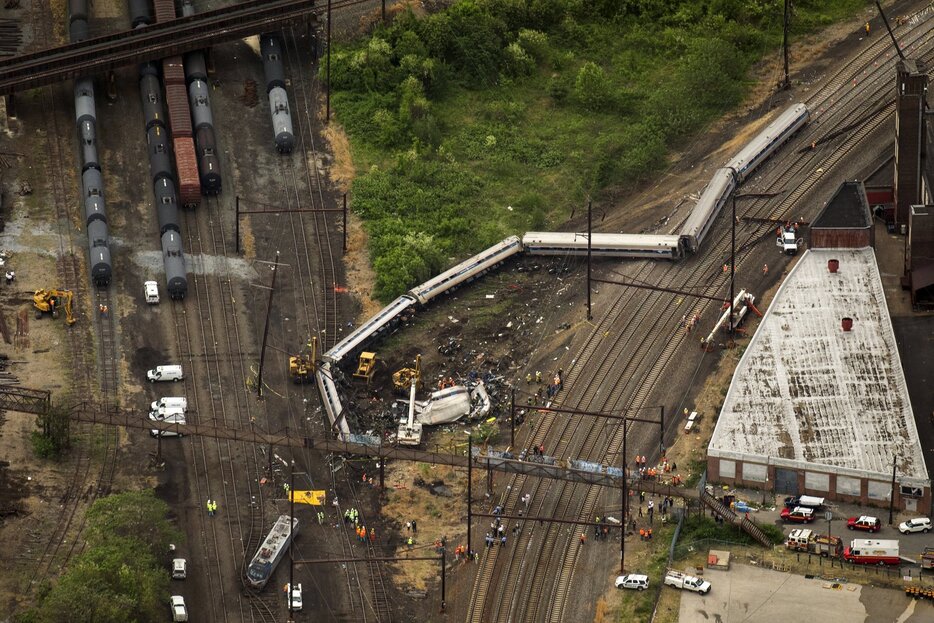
[381, 433, 468, 591]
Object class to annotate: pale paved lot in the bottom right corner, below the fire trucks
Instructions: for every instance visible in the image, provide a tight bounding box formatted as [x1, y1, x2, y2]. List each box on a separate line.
[678, 564, 934, 623]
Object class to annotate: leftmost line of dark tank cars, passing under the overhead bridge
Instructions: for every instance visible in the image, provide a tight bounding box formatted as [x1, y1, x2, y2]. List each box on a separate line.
[68, 0, 113, 286]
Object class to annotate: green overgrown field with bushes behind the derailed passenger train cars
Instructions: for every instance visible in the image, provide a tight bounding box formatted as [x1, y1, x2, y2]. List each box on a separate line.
[332, 0, 867, 300]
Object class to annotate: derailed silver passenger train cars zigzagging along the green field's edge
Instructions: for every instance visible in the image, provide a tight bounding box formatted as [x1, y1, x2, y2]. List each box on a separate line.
[316, 104, 810, 439]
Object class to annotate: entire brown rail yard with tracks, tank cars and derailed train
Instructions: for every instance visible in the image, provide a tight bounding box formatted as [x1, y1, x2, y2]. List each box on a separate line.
[0, 0, 934, 623]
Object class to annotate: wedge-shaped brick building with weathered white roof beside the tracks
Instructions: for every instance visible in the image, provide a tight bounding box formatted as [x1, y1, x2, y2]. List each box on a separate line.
[707, 182, 931, 512]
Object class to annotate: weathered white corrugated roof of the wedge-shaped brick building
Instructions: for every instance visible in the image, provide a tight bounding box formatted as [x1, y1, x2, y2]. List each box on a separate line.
[708, 248, 929, 485]
